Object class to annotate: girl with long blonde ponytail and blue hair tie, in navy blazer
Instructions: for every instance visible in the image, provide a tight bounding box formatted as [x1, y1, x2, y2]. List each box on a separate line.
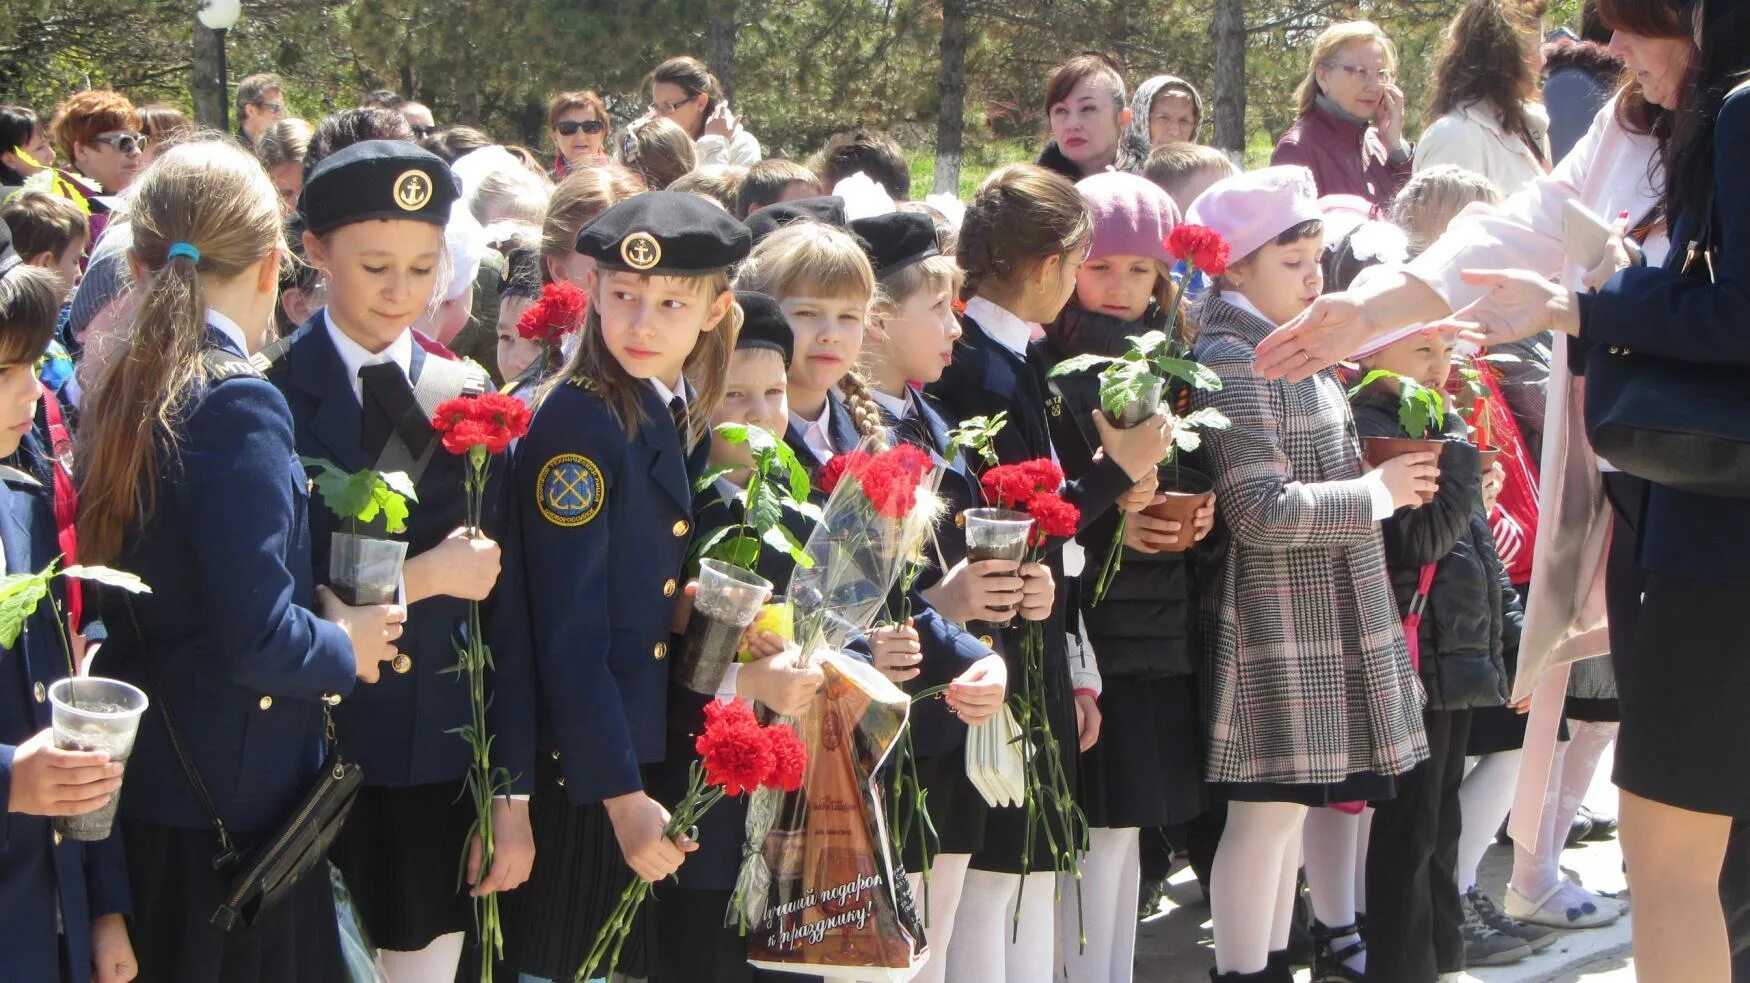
[79, 142, 404, 983]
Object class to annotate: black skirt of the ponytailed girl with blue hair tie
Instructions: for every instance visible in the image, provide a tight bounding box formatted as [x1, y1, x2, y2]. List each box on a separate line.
[117, 819, 348, 983]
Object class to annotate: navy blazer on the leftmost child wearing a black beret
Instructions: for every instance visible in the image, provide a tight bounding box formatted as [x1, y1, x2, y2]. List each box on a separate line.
[268, 311, 534, 792]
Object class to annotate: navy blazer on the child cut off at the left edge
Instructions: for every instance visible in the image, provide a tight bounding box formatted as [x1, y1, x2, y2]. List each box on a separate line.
[0, 467, 127, 983]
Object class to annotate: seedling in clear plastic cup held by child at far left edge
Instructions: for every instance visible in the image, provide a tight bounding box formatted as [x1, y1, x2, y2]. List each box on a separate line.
[0, 560, 152, 840]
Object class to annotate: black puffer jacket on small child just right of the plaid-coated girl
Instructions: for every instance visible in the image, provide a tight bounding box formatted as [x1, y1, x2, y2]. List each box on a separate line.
[1355, 388, 1524, 710]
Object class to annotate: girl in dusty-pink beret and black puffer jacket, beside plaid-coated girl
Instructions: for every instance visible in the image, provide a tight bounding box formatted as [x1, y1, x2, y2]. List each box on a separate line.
[1034, 171, 1215, 983]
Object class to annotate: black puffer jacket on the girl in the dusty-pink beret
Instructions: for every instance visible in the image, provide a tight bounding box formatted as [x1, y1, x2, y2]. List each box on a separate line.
[1033, 306, 1222, 679]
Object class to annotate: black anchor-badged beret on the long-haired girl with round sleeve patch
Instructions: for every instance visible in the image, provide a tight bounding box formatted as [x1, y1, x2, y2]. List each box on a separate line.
[578, 191, 753, 276]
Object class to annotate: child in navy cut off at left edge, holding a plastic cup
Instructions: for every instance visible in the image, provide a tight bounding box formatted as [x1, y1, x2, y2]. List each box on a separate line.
[0, 262, 138, 983]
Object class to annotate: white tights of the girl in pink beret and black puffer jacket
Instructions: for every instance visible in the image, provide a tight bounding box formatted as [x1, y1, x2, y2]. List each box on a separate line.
[1057, 826, 1143, 983]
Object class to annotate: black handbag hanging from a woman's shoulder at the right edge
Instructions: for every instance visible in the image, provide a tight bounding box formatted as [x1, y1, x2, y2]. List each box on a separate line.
[1586, 191, 1750, 498]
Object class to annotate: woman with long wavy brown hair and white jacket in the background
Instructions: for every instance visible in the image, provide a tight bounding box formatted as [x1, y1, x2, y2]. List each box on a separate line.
[1416, 0, 1549, 196]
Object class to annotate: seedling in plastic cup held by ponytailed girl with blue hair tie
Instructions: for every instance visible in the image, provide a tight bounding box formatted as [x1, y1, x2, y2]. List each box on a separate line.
[298, 458, 418, 607]
